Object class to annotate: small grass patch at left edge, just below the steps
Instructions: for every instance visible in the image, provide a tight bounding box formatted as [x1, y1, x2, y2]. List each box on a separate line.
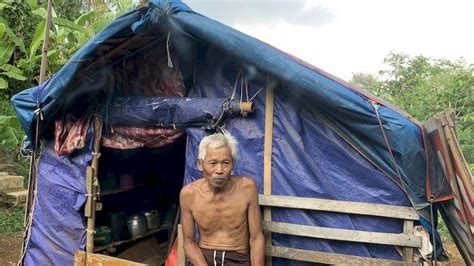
[0, 207, 25, 237]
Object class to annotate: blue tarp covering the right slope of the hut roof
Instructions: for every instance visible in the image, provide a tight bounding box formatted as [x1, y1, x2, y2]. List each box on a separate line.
[174, 8, 449, 209]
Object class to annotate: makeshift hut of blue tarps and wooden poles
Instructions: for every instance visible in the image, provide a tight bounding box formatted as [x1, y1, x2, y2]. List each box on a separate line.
[13, 0, 470, 265]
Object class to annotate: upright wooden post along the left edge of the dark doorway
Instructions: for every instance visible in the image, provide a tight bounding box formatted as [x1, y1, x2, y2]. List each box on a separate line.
[84, 117, 102, 253]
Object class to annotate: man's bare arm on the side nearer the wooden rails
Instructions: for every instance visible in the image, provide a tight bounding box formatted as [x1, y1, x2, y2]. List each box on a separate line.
[247, 179, 265, 266]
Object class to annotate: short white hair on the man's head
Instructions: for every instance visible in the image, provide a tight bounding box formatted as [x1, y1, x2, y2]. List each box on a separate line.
[198, 131, 238, 162]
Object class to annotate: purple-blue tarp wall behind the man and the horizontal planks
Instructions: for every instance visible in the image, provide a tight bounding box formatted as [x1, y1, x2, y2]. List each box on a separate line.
[185, 59, 411, 260]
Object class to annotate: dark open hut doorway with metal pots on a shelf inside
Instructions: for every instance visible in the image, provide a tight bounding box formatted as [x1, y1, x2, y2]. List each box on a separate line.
[88, 136, 186, 265]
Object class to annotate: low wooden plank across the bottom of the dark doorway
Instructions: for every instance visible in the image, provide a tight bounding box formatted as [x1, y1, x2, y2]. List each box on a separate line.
[74, 251, 146, 266]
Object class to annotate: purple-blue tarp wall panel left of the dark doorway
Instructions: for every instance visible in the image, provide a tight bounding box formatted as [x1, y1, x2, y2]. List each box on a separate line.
[24, 134, 92, 265]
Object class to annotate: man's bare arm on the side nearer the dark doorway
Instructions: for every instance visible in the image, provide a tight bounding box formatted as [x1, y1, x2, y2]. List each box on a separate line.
[179, 186, 207, 266]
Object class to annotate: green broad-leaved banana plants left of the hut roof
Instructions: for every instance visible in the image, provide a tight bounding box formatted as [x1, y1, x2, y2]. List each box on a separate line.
[0, 0, 132, 149]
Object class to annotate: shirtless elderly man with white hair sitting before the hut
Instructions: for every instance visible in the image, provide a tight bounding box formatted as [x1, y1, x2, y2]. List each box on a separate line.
[180, 133, 264, 266]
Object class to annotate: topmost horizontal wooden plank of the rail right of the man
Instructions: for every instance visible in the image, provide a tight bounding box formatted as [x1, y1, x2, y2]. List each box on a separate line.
[259, 195, 419, 221]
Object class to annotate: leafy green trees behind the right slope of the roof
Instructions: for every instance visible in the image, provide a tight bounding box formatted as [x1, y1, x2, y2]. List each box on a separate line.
[351, 53, 474, 163]
